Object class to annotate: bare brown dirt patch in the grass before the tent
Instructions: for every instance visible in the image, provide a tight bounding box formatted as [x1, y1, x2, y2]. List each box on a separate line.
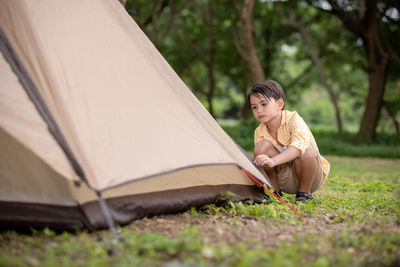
[128, 213, 400, 248]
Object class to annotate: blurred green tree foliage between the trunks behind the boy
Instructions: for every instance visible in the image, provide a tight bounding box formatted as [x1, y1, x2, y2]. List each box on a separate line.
[126, 0, 400, 137]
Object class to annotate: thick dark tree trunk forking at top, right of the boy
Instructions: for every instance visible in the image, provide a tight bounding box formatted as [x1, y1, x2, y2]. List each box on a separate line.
[307, 0, 399, 141]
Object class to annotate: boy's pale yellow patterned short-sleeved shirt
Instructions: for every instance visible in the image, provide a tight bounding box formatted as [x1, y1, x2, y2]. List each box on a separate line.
[254, 110, 330, 187]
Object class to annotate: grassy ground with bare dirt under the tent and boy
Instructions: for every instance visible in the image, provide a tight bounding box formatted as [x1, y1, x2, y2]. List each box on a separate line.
[0, 156, 400, 266]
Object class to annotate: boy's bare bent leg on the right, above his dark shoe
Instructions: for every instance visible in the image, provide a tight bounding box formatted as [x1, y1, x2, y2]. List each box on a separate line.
[293, 144, 319, 194]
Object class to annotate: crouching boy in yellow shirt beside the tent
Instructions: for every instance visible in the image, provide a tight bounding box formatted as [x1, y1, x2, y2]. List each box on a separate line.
[248, 80, 330, 201]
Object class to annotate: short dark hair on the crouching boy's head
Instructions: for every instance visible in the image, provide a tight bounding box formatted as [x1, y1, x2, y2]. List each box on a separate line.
[247, 80, 285, 109]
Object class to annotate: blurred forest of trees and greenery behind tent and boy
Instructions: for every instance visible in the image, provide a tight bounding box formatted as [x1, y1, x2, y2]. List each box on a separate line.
[120, 0, 400, 157]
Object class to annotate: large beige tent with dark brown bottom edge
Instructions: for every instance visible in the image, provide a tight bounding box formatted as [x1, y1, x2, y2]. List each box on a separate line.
[0, 0, 268, 232]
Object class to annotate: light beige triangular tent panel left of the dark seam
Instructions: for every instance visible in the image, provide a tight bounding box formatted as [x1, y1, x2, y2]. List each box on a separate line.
[0, 36, 75, 184]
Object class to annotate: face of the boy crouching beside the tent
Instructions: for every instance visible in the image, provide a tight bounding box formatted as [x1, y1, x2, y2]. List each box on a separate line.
[250, 95, 284, 123]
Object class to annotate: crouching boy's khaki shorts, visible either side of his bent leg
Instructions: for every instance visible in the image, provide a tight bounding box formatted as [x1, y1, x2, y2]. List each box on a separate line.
[275, 155, 324, 194]
